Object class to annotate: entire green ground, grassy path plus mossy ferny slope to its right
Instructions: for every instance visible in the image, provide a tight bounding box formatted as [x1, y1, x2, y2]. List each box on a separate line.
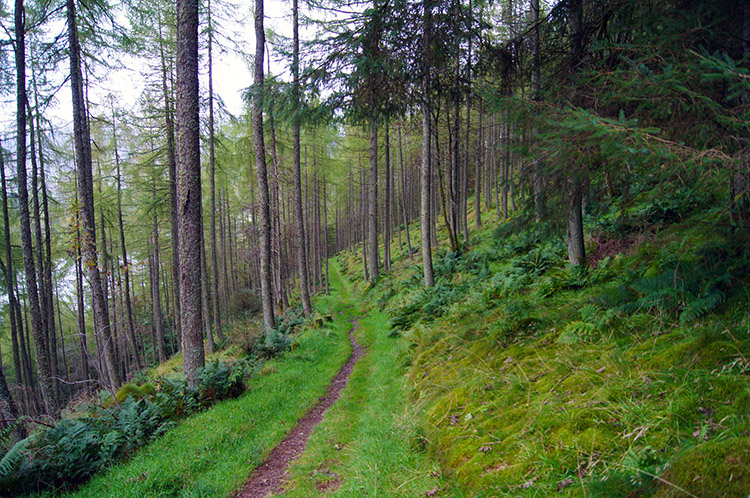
[51, 201, 750, 498]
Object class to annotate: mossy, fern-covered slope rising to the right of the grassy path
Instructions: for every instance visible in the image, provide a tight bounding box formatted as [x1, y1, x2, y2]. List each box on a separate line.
[339, 205, 750, 497]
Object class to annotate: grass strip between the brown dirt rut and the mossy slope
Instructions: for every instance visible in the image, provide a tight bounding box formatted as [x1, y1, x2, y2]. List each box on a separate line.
[282, 269, 458, 498]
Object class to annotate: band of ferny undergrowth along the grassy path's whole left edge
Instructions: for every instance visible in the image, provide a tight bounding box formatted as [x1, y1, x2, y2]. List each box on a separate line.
[0, 300, 312, 495]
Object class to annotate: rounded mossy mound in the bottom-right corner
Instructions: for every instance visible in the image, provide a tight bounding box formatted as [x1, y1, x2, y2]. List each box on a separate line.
[655, 438, 750, 498]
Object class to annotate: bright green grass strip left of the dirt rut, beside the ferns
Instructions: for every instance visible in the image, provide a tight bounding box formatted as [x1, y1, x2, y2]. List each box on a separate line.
[43, 278, 358, 498]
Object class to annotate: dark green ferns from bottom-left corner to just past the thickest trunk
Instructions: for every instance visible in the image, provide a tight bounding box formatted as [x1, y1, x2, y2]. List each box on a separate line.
[5, 360, 248, 493]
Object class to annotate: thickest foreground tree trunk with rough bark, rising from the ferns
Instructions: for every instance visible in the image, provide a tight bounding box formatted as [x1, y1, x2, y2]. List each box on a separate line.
[176, 0, 205, 387]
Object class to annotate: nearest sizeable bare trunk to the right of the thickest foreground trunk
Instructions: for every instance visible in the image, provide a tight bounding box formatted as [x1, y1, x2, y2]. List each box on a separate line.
[253, 0, 275, 331]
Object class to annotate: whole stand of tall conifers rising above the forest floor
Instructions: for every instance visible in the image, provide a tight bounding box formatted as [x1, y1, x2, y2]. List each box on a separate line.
[0, 0, 750, 428]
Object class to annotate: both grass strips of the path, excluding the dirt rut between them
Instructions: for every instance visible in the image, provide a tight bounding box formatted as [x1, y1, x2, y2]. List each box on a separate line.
[44, 265, 459, 498]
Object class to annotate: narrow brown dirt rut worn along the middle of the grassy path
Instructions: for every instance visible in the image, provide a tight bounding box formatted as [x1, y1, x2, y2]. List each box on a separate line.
[234, 319, 365, 498]
